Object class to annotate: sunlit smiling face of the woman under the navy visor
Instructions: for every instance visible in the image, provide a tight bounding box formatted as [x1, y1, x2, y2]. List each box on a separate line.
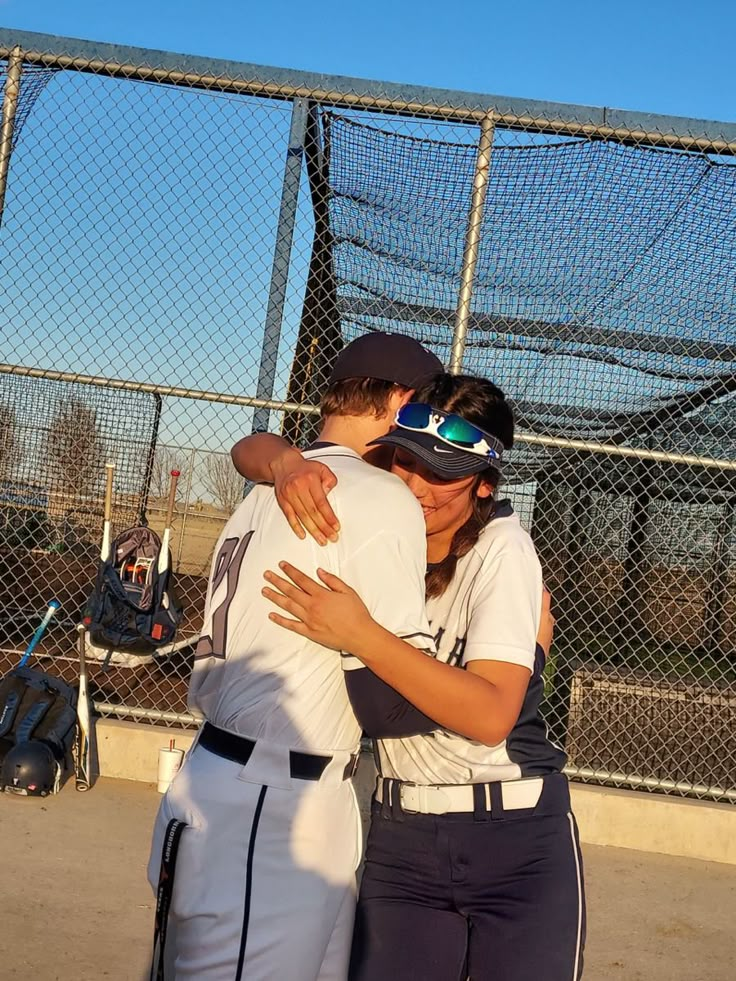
[391, 449, 493, 536]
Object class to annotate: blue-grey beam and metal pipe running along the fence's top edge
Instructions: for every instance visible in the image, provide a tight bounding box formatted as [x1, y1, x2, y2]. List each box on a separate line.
[0, 27, 736, 155]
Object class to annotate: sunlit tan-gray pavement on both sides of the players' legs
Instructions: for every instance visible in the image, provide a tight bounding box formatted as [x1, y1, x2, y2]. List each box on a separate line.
[0, 779, 736, 981]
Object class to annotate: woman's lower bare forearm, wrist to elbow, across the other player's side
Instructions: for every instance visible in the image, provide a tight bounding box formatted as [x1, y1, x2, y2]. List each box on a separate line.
[350, 623, 508, 746]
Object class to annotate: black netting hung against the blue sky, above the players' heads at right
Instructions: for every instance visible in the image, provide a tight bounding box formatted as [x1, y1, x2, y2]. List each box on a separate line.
[325, 115, 736, 444]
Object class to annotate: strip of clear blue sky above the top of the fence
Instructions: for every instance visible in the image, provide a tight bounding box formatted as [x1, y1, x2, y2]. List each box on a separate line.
[0, 0, 736, 121]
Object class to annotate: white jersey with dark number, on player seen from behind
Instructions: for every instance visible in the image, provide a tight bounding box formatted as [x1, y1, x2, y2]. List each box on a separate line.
[189, 444, 432, 752]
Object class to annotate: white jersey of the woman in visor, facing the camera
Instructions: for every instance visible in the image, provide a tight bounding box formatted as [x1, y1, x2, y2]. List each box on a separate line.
[377, 507, 558, 784]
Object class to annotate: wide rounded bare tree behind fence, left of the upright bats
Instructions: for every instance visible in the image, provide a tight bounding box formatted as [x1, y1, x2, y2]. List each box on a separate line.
[46, 399, 105, 497]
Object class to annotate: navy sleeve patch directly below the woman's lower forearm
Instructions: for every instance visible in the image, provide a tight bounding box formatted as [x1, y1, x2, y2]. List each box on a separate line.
[345, 668, 439, 739]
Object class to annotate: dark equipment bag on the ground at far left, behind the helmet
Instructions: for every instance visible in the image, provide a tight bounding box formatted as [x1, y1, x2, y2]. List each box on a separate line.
[0, 668, 77, 766]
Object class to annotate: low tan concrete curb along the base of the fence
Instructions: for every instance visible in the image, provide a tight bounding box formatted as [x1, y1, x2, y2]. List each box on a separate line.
[96, 719, 736, 865]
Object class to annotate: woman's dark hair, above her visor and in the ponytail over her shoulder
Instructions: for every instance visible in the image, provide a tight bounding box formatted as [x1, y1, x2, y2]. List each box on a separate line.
[412, 374, 514, 599]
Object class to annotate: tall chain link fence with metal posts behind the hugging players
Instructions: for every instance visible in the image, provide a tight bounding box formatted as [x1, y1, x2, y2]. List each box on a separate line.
[0, 30, 736, 802]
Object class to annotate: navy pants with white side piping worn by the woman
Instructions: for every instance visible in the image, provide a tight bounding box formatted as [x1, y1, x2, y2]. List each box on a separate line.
[350, 774, 585, 981]
